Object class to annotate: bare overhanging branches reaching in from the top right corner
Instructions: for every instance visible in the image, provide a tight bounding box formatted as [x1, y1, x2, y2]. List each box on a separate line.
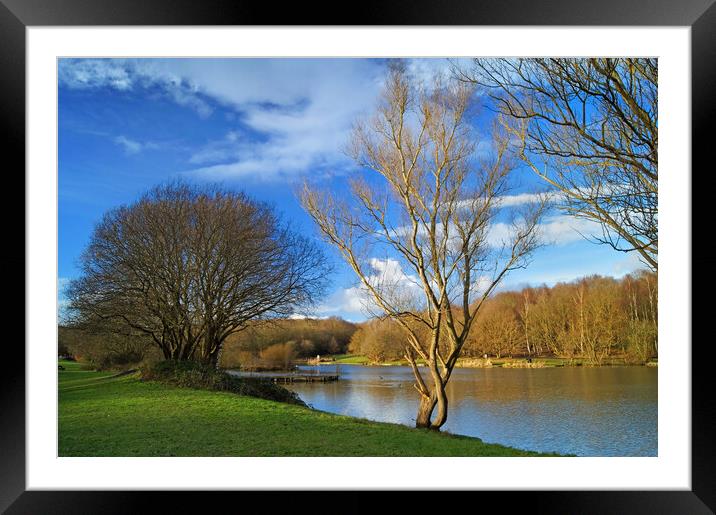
[456, 58, 659, 270]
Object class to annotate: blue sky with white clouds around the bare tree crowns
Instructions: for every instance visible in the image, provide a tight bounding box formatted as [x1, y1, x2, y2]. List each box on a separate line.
[58, 59, 640, 321]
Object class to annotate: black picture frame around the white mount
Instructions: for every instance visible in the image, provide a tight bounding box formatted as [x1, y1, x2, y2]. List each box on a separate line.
[0, 0, 716, 514]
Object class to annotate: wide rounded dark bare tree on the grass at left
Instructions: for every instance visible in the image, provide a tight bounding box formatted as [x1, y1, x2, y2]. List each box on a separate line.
[68, 183, 327, 365]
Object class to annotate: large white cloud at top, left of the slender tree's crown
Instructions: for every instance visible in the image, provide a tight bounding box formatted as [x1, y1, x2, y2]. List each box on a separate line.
[183, 59, 382, 180]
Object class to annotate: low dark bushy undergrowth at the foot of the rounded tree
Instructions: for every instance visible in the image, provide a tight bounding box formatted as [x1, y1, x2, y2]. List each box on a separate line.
[141, 360, 306, 406]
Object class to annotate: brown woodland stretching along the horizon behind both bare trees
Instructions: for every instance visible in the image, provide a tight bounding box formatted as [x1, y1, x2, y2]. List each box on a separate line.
[60, 271, 658, 368]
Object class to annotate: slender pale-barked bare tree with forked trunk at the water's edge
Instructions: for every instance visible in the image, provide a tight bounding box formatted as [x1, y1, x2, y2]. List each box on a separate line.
[301, 68, 544, 429]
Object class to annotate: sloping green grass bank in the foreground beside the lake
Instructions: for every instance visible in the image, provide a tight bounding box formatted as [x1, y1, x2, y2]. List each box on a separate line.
[59, 362, 552, 456]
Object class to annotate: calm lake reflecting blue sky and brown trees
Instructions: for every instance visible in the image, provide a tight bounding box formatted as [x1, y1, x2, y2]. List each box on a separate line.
[278, 365, 658, 456]
